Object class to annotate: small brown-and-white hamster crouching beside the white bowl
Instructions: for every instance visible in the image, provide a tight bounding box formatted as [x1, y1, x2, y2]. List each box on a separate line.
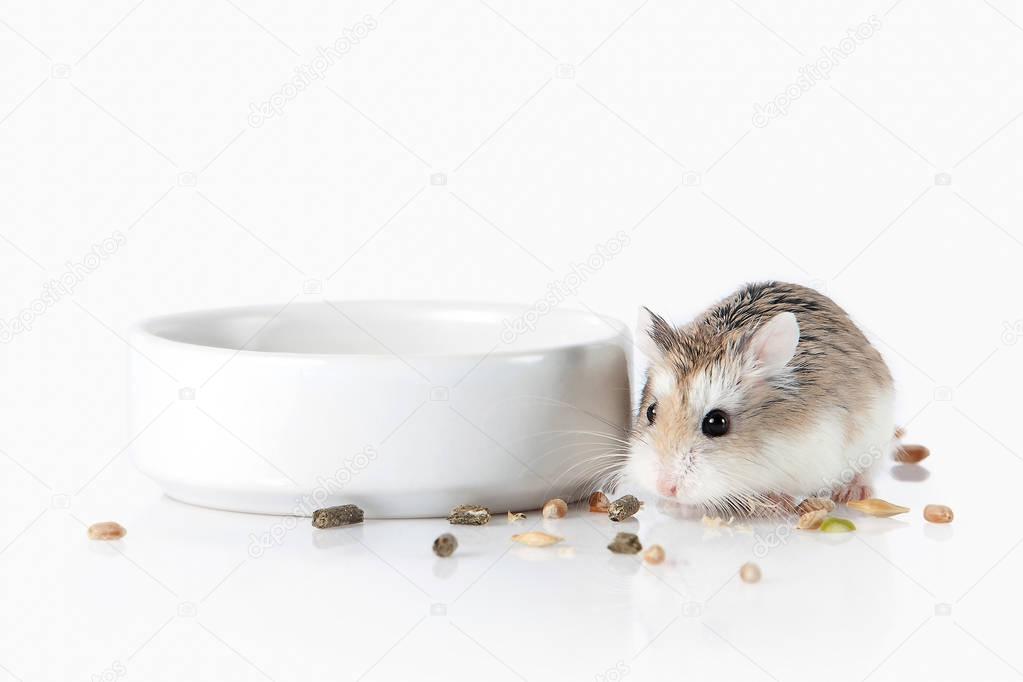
[624, 282, 897, 514]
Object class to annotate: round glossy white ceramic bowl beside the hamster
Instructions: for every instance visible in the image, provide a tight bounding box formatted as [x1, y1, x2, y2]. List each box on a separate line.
[129, 302, 631, 517]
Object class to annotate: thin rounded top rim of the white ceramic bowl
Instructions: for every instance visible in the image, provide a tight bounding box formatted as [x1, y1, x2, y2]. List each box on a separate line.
[129, 299, 633, 362]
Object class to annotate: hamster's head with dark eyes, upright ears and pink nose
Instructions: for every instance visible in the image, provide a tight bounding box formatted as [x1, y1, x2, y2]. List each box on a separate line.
[625, 308, 799, 509]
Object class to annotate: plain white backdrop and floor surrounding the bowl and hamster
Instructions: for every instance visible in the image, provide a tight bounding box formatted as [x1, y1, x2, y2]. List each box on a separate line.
[0, 0, 1023, 680]
